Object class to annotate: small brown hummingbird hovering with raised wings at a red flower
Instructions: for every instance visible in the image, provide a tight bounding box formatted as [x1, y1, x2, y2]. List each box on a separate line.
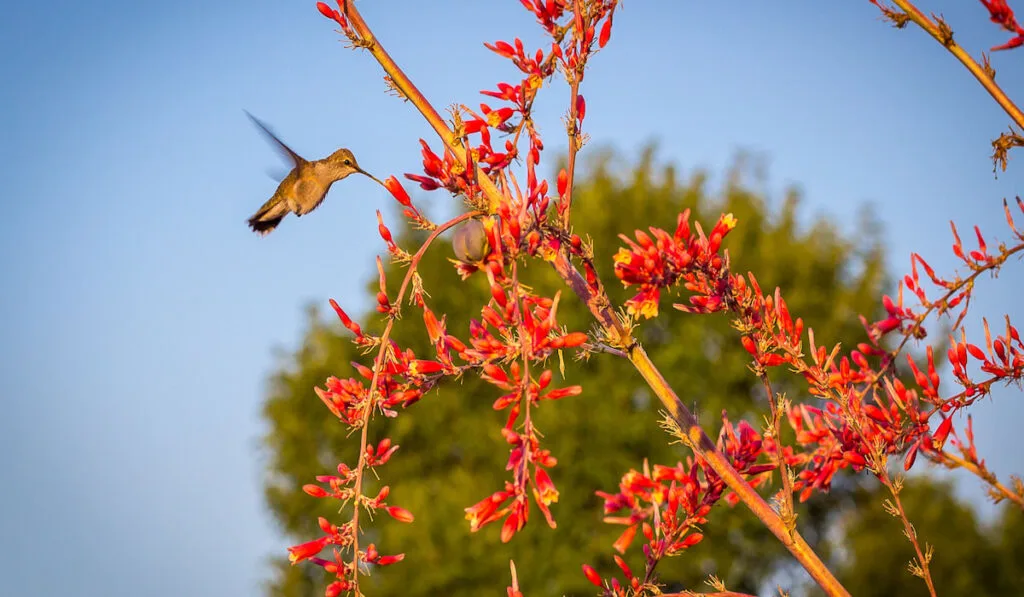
[246, 112, 384, 237]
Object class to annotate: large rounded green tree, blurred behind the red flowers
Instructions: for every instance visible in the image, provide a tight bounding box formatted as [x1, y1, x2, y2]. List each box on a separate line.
[263, 150, 902, 597]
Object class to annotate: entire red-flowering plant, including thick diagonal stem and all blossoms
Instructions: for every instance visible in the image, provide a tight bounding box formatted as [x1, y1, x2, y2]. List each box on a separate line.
[280, 0, 1024, 597]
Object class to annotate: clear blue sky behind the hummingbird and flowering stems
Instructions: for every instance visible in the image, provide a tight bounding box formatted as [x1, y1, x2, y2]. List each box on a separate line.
[0, 0, 1024, 597]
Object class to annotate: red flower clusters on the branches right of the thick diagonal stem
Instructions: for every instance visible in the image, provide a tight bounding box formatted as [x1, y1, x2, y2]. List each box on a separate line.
[585, 199, 1024, 595]
